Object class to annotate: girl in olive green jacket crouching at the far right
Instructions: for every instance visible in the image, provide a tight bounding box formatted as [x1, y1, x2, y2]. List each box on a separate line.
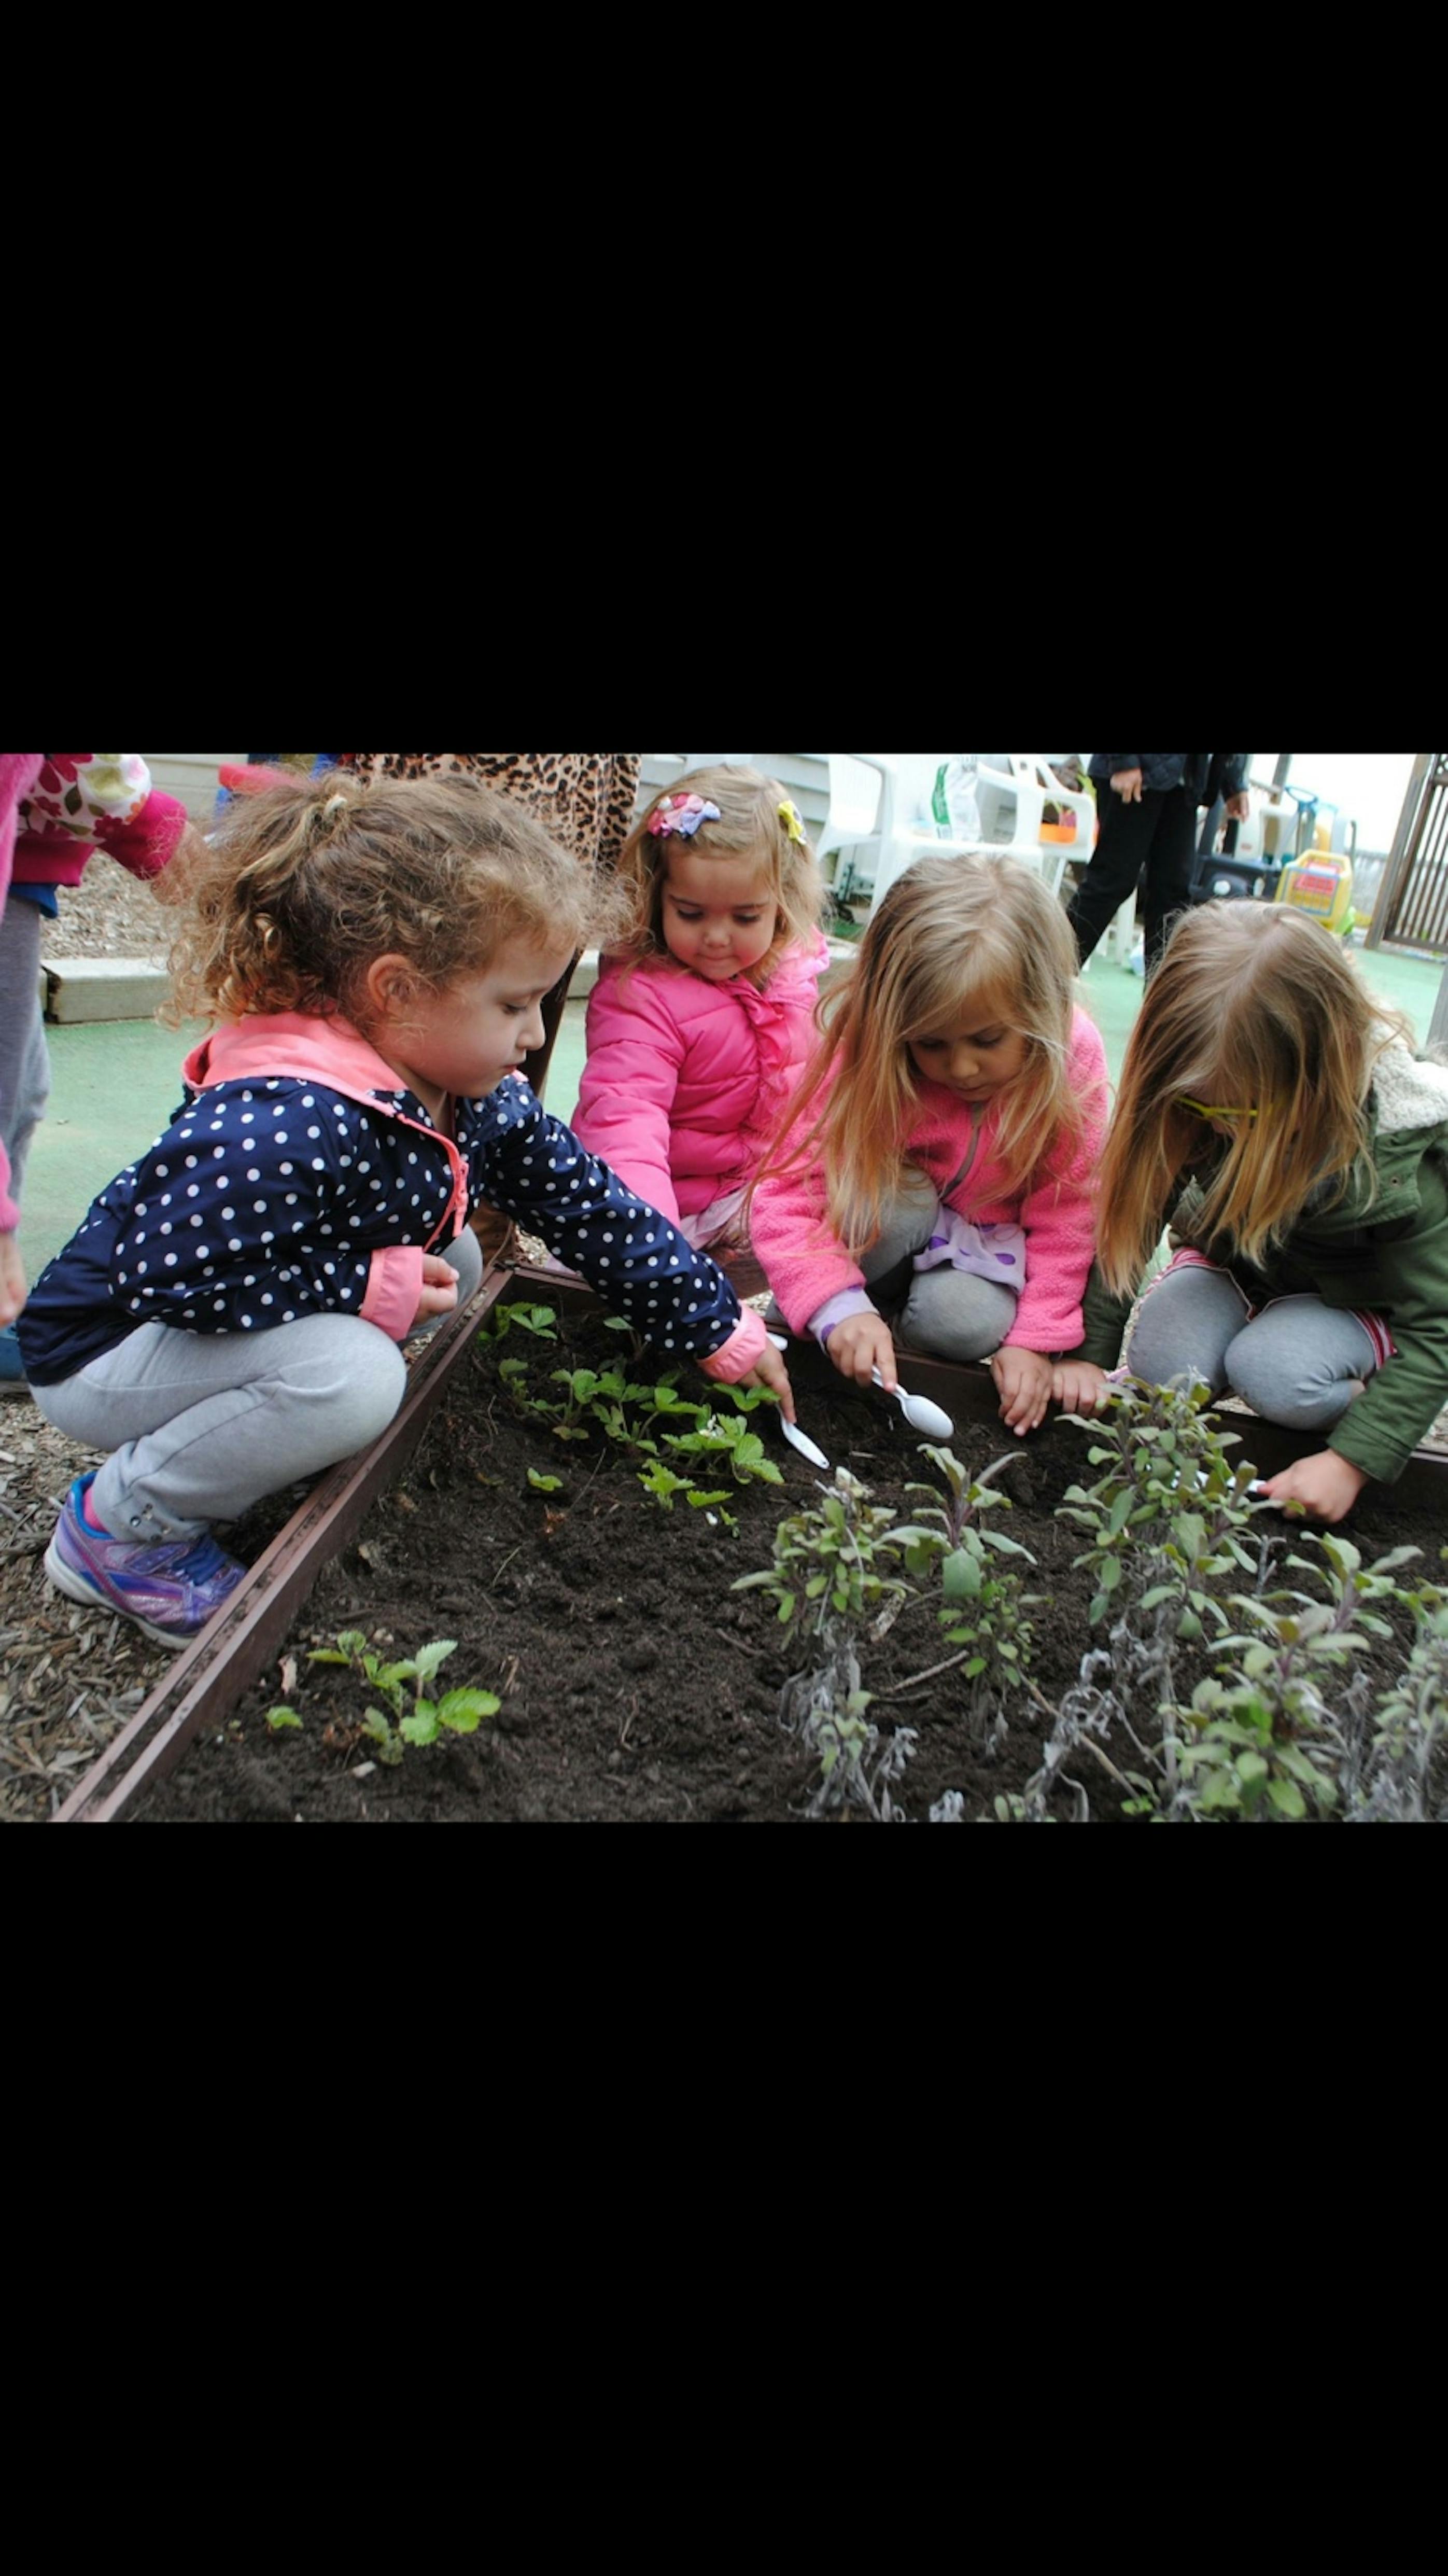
[1057, 904, 1448, 1522]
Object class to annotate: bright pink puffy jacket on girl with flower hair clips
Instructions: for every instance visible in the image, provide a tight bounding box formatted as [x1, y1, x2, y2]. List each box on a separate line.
[572, 940, 830, 1226]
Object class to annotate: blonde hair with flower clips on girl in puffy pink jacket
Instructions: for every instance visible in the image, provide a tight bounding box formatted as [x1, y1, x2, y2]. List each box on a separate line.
[602, 765, 824, 989]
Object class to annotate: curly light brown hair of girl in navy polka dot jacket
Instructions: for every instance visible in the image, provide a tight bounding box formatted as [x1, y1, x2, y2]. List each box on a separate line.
[167, 770, 621, 1033]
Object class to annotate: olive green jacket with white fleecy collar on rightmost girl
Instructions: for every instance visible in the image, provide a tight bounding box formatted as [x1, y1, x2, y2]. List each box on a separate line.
[1074, 1046, 1448, 1484]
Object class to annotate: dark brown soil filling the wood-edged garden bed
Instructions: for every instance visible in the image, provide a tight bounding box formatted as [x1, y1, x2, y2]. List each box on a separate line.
[136, 1314, 1440, 1824]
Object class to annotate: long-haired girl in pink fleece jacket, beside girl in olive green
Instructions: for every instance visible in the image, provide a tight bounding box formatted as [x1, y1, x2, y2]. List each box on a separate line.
[752, 858, 1108, 1435]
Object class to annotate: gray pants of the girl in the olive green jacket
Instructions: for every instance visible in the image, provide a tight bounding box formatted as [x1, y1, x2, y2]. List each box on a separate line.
[1126, 1267, 1379, 1432]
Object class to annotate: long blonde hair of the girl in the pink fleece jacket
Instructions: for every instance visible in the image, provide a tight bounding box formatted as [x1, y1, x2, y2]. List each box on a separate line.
[768, 858, 1085, 1257]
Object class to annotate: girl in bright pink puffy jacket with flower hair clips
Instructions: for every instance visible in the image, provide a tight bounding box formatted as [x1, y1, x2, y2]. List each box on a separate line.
[574, 767, 830, 1249]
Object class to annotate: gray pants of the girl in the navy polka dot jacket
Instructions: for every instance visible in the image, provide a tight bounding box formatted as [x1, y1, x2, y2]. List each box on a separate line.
[34, 1234, 482, 1541]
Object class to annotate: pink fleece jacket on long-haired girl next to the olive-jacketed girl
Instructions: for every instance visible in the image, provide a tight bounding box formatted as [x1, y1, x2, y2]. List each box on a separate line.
[752, 1010, 1108, 1352]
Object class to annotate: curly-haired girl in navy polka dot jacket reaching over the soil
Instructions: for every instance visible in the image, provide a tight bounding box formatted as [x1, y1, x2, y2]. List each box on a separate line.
[21, 775, 794, 1646]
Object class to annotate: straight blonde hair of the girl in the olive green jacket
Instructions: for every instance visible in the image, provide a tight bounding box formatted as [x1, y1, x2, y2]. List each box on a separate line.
[1098, 904, 1412, 1296]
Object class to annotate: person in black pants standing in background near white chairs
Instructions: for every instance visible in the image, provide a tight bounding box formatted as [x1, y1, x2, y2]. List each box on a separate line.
[1069, 752, 1252, 976]
